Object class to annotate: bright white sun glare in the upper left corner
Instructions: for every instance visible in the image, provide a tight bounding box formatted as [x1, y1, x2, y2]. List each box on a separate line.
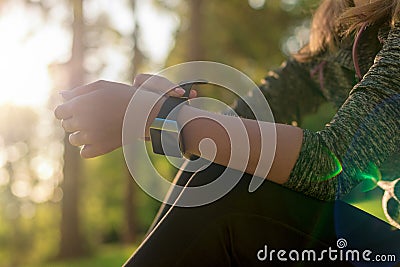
[0, 5, 69, 106]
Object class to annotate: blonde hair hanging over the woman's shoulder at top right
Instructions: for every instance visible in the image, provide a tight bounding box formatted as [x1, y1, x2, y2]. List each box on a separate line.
[296, 0, 400, 60]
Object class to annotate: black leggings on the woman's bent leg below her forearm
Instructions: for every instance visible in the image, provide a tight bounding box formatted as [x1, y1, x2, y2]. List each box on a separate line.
[126, 164, 400, 267]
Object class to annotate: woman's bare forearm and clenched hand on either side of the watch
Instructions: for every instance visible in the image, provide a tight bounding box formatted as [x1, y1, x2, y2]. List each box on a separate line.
[55, 77, 302, 183]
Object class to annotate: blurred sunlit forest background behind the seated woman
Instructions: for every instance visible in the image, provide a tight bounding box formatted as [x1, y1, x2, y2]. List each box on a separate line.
[0, 0, 386, 267]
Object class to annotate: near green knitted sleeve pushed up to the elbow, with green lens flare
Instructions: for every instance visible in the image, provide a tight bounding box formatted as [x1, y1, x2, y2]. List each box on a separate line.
[284, 23, 400, 200]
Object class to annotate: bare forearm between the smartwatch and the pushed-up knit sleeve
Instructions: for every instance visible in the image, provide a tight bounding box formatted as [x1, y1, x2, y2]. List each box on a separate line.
[178, 106, 302, 183]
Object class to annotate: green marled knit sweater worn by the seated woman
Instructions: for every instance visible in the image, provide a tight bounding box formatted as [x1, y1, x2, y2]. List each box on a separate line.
[235, 23, 400, 200]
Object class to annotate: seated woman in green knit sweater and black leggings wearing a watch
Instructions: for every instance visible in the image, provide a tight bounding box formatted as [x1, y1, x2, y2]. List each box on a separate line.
[55, 0, 400, 266]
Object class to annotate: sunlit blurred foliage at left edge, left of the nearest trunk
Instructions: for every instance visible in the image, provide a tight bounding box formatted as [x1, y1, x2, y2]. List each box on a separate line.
[0, 105, 61, 266]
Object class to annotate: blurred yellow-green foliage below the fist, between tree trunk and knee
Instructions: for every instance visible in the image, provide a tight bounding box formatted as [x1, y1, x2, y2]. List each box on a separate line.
[81, 149, 162, 246]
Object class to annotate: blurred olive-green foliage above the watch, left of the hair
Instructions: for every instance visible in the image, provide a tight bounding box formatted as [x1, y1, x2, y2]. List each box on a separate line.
[167, 0, 317, 81]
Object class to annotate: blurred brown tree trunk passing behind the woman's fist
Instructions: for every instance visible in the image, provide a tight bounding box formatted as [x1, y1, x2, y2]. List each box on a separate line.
[58, 0, 88, 259]
